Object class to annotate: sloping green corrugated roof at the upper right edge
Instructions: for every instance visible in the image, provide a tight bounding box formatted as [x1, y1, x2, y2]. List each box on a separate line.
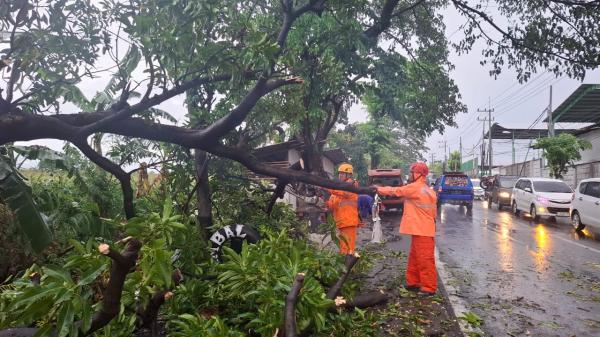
[544, 84, 600, 123]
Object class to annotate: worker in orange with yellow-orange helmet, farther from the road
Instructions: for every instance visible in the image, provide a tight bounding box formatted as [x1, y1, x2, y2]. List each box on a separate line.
[326, 164, 360, 254]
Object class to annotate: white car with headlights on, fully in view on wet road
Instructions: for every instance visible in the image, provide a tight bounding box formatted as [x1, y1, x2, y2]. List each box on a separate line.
[511, 178, 573, 220]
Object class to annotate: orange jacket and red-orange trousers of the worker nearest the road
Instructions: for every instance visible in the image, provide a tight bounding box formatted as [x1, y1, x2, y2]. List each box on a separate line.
[377, 177, 437, 293]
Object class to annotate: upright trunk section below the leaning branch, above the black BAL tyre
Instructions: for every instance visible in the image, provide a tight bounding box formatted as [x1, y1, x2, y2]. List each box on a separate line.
[194, 150, 212, 238]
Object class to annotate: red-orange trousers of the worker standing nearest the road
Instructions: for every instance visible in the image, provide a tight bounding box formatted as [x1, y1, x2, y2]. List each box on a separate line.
[406, 235, 437, 293]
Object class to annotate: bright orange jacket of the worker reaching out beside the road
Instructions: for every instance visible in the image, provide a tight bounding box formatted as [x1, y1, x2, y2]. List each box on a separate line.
[377, 177, 437, 237]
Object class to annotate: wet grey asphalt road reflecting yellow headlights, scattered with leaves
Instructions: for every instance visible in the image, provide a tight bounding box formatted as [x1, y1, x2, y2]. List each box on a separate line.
[436, 202, 600, 337]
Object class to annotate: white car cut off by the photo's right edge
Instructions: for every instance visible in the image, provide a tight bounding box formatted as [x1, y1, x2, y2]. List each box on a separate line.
[571, 178, 600, 231]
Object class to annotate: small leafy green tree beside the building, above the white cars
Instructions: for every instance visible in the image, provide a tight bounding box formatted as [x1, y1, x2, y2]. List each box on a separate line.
[533, 133, 592, 179]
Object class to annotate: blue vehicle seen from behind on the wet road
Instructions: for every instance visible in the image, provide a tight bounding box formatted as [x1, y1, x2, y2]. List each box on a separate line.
[434, 172, 473, 211]
